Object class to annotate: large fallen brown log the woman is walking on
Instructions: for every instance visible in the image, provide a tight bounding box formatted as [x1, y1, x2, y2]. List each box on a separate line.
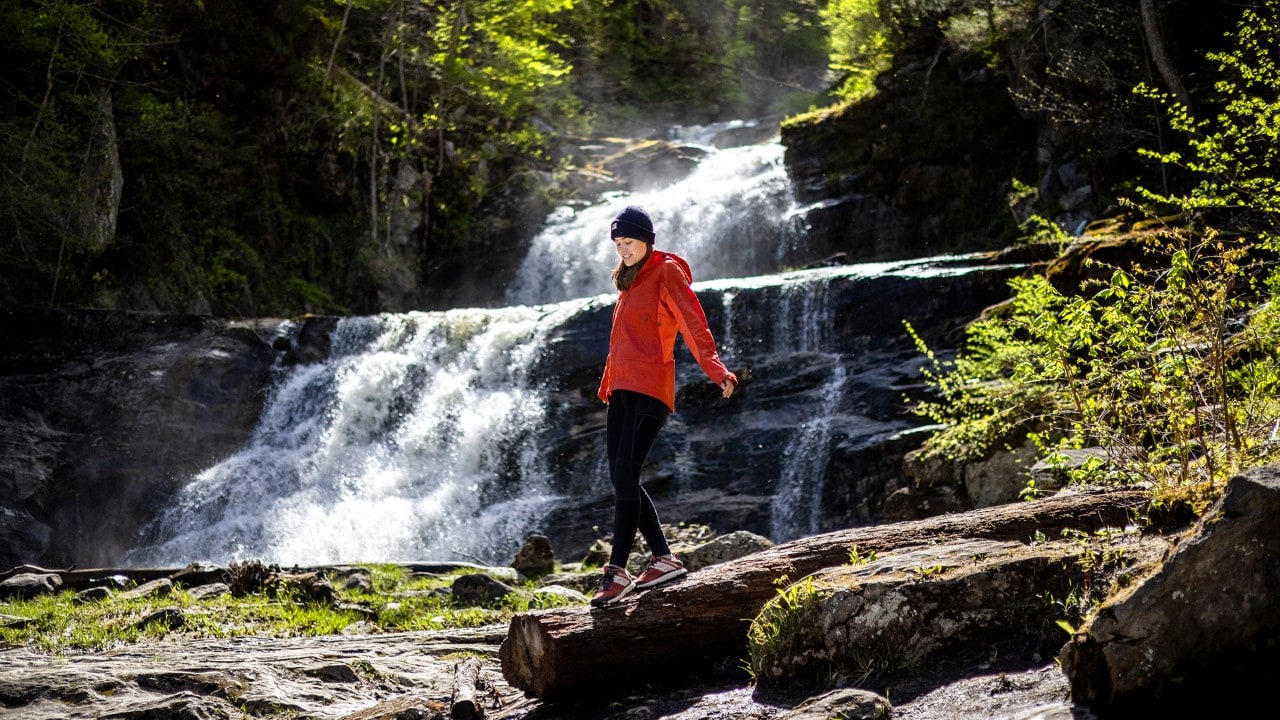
[498, 491, 1147, 700]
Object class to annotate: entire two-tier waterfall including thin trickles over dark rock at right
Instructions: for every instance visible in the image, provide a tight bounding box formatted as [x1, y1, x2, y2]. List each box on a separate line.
[127, 120, 1018, 565]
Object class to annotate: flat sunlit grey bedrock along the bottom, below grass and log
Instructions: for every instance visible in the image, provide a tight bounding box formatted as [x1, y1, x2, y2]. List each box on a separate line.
[0, 625, 1091, 720]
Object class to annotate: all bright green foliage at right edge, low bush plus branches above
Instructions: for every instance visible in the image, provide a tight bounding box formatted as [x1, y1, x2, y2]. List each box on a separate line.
[909, 0, 1280, 507]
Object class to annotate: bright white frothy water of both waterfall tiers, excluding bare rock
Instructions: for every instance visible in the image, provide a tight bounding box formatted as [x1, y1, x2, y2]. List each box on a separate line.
[127, 117, 988, 565]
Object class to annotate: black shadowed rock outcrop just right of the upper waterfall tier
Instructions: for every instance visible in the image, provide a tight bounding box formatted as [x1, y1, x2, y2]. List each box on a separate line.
[782, 51, 1037, 263]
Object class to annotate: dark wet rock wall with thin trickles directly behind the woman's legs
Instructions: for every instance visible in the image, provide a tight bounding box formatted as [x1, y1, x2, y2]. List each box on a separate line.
[535, 257, 1016, 556]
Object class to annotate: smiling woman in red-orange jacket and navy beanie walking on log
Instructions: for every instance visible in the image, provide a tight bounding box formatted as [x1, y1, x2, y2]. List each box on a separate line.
[591, 206, 737, 605]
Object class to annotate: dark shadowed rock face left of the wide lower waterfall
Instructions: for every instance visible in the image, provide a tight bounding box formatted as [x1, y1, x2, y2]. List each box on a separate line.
[0, 311, 280, 568]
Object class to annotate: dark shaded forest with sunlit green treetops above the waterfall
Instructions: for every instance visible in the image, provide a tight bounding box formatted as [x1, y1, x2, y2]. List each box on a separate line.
[0, 0, 1259, 316]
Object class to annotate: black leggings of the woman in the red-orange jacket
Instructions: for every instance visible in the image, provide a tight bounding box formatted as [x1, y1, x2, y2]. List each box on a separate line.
[605, 389, 671, 568]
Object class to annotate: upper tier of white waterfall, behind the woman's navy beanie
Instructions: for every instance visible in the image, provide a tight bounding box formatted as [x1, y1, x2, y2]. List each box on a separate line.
[507, 128, 797, 305]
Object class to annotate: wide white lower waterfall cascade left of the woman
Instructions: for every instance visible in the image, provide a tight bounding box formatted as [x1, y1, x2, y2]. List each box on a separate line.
[128, 301, 590, 565]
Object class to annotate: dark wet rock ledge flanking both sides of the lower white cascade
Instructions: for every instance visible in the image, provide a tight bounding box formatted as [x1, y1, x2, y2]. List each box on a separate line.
[0, 254, 1018, 566]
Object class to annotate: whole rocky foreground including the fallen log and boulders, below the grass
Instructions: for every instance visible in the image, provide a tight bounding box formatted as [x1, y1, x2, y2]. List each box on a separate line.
[0, 465, 1280, 720]
